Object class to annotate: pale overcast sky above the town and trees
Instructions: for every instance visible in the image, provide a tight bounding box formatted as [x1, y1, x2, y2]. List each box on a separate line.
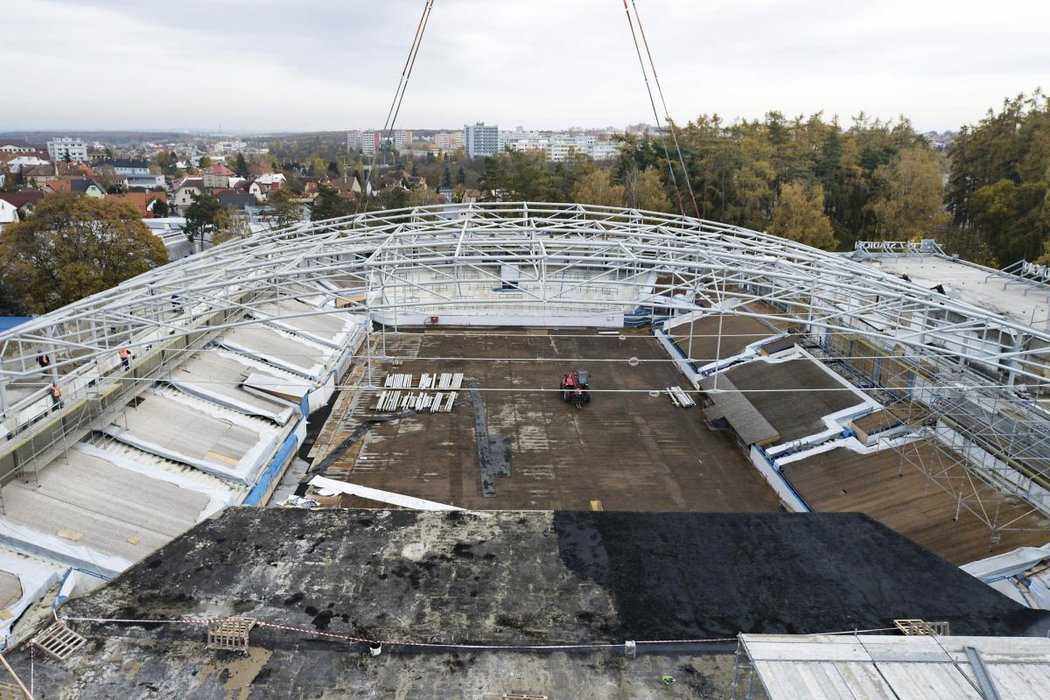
[0, 0, 1050, 132]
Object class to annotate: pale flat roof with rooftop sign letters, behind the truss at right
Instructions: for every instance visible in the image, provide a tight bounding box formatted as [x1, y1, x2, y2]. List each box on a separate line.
[860, 255, 1050, 331]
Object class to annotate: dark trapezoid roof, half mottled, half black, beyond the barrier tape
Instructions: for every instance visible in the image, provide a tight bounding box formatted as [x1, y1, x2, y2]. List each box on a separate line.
[61, 508, 1050, 644]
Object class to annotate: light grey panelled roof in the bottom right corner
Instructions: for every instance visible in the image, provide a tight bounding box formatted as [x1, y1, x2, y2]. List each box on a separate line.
[741, 635, 1050, 700]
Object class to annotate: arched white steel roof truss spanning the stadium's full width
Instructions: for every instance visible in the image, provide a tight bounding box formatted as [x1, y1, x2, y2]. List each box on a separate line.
[0, 203, 1050, 394]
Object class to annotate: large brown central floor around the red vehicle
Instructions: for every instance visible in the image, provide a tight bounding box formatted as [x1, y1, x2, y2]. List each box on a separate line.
[315, 331, 778, 512]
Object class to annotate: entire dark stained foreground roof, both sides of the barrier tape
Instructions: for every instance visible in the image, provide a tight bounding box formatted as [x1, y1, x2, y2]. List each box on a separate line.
[8, 508, 1050, 698]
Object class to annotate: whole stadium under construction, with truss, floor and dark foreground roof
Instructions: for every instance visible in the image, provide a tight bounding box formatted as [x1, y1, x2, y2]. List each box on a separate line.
[0, 203, 1050, 698]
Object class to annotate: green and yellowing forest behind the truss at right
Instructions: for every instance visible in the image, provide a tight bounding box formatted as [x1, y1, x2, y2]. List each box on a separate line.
[480, 90, 1050, 266]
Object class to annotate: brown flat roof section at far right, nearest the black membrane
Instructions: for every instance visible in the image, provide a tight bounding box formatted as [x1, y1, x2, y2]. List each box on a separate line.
[782, 441, 1050, 565]
